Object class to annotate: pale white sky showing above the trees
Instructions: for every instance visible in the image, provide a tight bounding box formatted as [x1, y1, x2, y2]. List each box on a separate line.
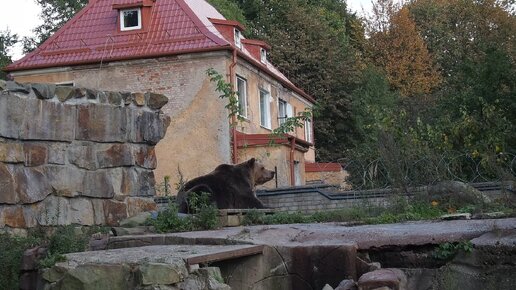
[0, 0, 371, 60]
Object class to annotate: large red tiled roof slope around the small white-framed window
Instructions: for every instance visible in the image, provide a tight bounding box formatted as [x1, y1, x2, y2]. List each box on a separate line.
[7, 0, 229, 71]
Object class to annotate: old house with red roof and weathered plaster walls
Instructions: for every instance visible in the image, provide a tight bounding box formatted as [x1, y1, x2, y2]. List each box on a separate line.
[5, 0, 336, 187]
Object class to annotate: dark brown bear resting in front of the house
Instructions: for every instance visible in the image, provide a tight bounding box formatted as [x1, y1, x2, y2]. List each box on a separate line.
[176, 158, 274, 213]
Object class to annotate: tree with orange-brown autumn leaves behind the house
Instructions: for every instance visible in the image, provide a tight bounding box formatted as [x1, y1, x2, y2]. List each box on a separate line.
[368, 0, 440, 98]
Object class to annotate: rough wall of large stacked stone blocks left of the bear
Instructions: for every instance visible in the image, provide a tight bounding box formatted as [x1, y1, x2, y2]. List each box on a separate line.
[0, 82, 170, 228]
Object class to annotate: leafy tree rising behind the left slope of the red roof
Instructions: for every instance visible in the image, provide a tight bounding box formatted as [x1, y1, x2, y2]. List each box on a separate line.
[23, 0, 89, 52]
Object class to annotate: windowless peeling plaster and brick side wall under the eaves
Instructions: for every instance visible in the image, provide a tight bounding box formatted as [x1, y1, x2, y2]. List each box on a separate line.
[12, 51, 231, 187]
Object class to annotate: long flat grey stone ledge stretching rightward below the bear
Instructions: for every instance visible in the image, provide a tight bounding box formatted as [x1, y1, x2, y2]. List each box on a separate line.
[108, 218, 516, 249]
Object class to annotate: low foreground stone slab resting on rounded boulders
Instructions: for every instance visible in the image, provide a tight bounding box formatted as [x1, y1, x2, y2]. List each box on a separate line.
[41, 245, 264, 290]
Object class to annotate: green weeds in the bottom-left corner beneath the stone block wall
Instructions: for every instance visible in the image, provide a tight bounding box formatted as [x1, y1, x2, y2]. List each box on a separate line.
[0, 233, 40, 289]
